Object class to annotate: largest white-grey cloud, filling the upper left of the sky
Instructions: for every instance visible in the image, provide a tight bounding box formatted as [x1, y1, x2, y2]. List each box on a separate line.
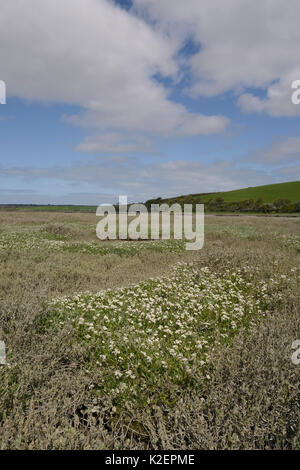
[0, 0, 228, 135]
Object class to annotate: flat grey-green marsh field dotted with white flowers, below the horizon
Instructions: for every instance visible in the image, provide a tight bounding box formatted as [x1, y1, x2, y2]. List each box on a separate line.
[0, 211, 300, 449]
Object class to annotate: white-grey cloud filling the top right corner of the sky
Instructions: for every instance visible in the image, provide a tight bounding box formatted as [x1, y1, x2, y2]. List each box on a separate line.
[134, 0, 300, 116]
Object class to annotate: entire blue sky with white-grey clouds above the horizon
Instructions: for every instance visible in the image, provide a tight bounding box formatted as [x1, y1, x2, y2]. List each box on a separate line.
[0, 0, 300, 205]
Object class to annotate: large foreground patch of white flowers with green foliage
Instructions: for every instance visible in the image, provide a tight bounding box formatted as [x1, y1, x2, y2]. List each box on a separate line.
[45, 263, 289, 403]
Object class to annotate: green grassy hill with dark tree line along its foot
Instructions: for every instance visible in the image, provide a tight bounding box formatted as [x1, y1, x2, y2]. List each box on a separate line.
[146, 181, 300, 212]
